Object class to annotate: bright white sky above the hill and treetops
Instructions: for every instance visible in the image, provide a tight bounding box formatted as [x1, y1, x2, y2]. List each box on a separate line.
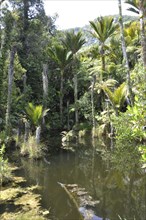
[44, 0, 134, 29]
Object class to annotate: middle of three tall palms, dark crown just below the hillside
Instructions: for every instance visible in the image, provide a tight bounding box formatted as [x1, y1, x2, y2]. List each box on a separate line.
[63, 30, 85, 125]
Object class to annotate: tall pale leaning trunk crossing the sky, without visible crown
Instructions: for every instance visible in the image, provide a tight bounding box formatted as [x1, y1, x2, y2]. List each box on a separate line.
[118, 0, 133, 105]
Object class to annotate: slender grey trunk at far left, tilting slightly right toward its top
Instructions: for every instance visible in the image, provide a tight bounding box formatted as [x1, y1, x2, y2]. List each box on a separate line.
[6, 46, 16, 132]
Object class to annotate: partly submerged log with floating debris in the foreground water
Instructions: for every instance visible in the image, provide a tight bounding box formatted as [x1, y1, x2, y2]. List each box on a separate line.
[58, 182, 102, 220]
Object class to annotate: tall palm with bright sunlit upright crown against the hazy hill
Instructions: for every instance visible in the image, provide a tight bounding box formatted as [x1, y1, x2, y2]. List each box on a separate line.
[90, 17, 118, 80]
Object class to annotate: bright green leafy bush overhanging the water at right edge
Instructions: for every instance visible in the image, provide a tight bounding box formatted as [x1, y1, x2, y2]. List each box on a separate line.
[113, 97, 145, 146]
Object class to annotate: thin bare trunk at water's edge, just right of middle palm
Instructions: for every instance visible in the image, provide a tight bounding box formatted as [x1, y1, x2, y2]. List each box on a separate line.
[91, 76, 96, 138]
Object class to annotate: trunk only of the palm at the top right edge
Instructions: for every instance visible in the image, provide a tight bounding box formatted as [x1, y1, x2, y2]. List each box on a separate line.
[139, 0, 146, 71]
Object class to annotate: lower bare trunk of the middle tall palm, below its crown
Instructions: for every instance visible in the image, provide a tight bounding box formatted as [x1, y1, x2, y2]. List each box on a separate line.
[74, 73, 79, 125]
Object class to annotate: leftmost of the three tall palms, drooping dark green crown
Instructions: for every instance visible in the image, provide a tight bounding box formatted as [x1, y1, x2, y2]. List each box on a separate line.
[48, 45, 72, 125]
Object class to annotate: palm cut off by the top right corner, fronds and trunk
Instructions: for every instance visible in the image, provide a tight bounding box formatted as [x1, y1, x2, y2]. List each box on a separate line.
[125, 0, 146, 70]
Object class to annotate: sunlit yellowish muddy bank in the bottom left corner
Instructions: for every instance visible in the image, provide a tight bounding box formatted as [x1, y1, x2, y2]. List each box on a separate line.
[0, 164, 49, 220]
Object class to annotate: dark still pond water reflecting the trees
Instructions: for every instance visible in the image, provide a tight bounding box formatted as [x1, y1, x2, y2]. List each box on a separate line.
[22, 139, 146, 220]
